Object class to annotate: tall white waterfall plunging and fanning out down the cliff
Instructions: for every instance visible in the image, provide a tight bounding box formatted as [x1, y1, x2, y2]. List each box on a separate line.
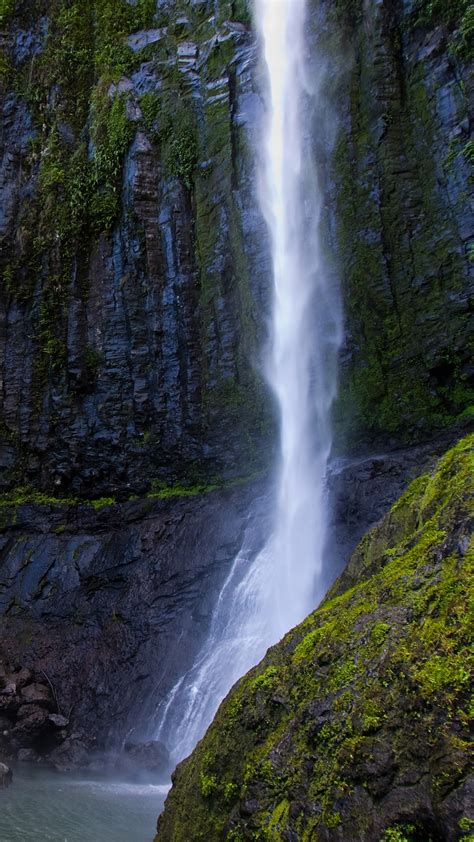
[156, 0, 341, 762]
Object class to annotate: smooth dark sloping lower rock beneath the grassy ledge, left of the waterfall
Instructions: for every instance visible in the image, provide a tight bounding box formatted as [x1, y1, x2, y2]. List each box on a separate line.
[0, 476, 266, 756]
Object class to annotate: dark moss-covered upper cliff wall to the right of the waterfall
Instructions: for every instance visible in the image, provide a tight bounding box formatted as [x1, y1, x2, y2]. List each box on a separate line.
[334, 0, 474, 446]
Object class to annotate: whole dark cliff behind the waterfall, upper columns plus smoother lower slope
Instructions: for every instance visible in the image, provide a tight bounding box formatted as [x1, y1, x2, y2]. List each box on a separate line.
[0, 0, 473, 780]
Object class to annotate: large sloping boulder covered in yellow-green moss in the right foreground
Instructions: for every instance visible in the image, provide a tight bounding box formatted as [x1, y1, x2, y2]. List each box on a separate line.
[156, 435, 474, 842]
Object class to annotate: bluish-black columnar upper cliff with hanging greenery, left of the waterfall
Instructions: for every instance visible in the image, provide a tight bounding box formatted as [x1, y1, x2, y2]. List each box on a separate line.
[0, 0, 269, 497]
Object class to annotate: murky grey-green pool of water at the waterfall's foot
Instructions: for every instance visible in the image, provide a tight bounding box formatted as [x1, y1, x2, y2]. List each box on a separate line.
[0, 767, 168, 842]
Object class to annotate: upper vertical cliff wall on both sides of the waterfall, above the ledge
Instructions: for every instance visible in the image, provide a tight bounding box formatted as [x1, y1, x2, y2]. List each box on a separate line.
[0, 0, 473, 497]
